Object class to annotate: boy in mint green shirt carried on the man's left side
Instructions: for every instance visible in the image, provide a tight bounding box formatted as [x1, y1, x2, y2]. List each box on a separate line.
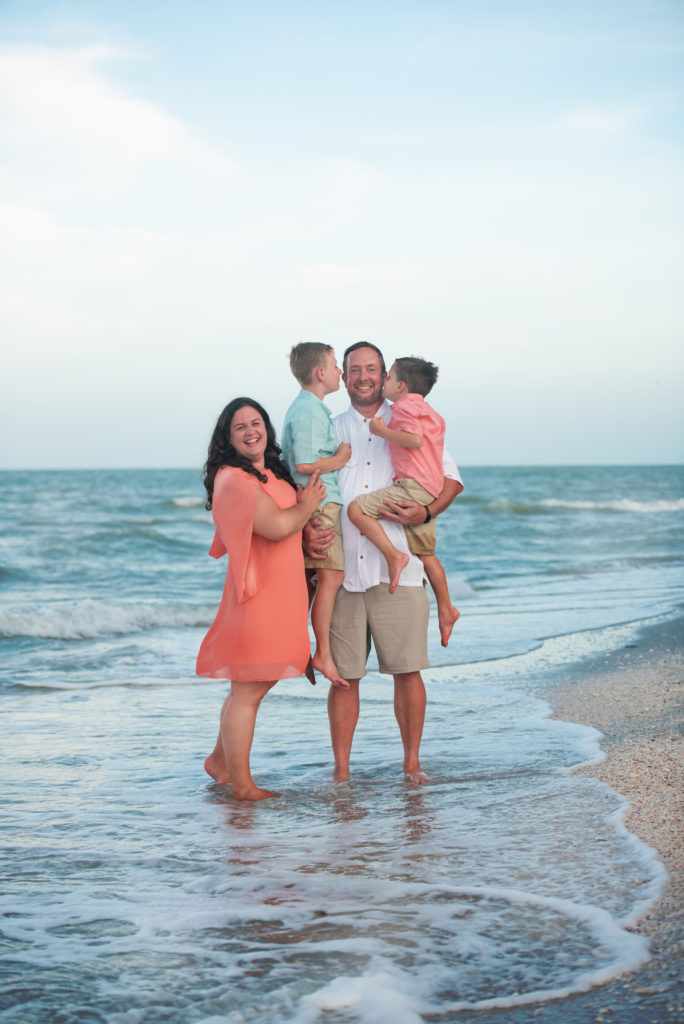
[281, 341, 351, 685]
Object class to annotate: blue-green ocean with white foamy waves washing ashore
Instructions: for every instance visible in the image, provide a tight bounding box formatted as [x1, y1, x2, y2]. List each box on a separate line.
[0, 466, 684, 1024]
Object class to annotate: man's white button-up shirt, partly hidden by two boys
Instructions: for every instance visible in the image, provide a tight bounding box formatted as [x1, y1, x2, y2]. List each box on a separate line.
[334, 401, 461, 591]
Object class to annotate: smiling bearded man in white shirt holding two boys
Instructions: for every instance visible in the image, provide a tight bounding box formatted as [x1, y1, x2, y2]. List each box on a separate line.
[304, 341, 463, 784]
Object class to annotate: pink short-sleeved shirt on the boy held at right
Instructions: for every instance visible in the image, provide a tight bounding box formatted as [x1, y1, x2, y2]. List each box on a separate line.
[389, 393, 445, 498]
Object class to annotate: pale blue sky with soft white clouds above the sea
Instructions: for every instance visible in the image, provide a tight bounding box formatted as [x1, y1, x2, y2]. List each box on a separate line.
[0, 0, 684, 469]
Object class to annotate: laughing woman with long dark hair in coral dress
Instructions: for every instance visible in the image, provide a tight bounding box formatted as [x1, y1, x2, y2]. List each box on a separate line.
[197, 398, 326, 800]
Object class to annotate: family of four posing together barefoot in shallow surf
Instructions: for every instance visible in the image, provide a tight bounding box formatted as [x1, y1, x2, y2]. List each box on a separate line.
[197, 341, 463, 800]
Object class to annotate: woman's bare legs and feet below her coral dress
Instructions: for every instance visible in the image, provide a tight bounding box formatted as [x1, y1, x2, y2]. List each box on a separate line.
[220, 681, 277, 800]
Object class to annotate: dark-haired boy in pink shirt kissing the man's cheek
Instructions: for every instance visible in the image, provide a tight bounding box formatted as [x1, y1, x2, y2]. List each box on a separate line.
[347, 356, 459, 647]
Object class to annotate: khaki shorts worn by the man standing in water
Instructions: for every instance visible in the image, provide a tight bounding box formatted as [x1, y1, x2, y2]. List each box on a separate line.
[330, 583, 430, 679]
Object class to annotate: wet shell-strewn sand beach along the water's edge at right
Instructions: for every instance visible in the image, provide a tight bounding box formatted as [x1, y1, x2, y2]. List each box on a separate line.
[473, 618, 684, 1024]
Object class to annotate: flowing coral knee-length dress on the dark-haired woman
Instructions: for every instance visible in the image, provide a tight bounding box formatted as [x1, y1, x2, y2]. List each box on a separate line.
[197, 466, 310, 682]
